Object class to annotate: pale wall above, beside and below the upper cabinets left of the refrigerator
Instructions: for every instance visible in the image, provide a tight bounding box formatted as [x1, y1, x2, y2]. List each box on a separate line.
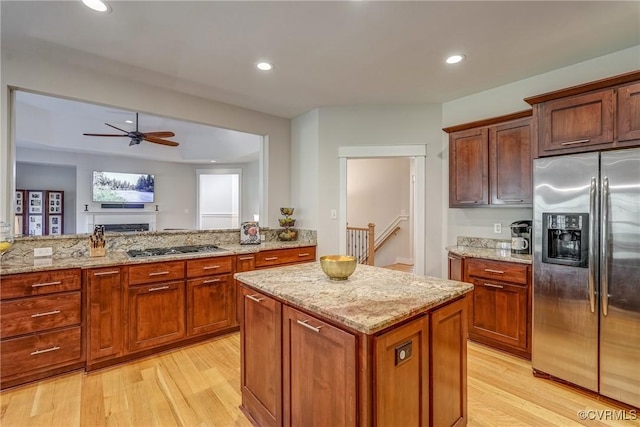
[441, 46, 640, 272]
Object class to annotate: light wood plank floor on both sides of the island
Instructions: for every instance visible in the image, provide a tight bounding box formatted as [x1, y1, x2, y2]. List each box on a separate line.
[0, 333, 640, 427]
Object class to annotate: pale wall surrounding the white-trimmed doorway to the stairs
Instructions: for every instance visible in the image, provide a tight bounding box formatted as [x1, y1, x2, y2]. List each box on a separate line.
[292, 105, 443, 276]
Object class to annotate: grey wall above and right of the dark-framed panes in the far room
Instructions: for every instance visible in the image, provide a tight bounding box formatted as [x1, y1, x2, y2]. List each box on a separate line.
[16, 163, 76, 234]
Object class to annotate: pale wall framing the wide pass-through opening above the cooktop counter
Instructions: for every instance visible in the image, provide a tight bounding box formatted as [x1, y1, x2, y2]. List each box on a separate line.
[0, 48, 291, 228]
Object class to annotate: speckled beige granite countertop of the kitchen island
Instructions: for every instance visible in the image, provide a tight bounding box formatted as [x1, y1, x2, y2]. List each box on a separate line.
[234, 262, 473, 334]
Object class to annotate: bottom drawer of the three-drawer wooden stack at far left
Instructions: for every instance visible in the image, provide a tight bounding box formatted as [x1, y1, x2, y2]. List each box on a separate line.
[1, 326, 83, 379]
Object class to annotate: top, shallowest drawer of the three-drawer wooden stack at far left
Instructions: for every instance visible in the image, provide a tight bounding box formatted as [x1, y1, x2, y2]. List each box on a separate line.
[0, 268, 80, 299]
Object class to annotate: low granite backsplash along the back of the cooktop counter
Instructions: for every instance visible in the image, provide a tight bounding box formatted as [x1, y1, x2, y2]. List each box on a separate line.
[2, 229, 317, 260]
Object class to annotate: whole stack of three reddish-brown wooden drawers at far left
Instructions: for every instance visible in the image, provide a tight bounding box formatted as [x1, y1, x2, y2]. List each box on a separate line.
[0, 269, 85, 388]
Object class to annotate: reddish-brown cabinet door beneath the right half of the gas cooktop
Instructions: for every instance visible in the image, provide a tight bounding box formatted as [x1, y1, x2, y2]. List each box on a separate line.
[187, 274, 234, 335]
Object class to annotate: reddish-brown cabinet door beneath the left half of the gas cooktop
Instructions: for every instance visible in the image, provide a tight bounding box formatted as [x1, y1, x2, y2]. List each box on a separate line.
[127, 281, 185, 351]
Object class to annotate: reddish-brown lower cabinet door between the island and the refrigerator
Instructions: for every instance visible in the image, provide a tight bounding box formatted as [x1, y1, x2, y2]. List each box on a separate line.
[469, 278, 527, 350]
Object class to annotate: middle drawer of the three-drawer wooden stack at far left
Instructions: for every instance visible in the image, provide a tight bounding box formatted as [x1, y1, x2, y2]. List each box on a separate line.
[0, 292, 81, 340]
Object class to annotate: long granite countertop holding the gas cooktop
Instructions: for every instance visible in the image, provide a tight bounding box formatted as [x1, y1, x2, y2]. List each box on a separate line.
[0, 241, 315, 275]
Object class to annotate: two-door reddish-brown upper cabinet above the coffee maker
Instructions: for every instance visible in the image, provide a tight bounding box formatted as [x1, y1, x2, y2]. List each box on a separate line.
[444, 110, 533, 208]
